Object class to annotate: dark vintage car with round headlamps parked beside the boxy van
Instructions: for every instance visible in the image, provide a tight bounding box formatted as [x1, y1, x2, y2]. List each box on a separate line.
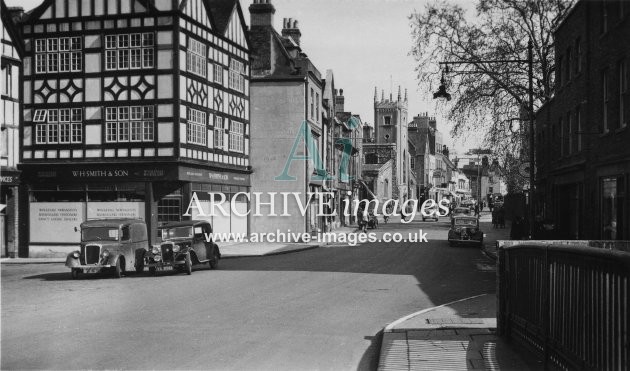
[145, 220, 221, 274]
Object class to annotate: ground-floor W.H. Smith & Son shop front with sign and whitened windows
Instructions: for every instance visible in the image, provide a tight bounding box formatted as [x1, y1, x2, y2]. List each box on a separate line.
[21, 163, 249, 257]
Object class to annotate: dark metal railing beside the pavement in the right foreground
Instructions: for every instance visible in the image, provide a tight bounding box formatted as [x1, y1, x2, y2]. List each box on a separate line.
[497, 241, 630, 370]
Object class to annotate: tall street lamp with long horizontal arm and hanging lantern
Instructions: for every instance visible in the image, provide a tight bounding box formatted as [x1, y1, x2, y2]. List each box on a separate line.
[433, 39, 536, 238]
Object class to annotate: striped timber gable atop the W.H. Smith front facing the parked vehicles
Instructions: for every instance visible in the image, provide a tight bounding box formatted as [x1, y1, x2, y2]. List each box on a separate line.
[32, 0, 153, 20]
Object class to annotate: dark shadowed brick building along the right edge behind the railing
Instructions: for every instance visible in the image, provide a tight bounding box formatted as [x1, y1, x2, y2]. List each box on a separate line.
[536, 0, 630, 240]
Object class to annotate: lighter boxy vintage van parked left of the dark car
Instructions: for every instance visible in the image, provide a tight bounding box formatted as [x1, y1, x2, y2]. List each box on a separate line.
[66, 219, 149, 279]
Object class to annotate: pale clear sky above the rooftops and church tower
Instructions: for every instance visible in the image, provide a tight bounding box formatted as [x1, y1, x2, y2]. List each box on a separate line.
[5, 0, 479, 153]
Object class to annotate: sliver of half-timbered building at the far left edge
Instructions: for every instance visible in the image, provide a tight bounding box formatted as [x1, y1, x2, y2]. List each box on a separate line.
[0, 1, 24, 257]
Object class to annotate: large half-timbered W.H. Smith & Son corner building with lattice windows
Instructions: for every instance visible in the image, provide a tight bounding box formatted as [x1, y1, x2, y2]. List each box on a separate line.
[21, 0, 250, 256]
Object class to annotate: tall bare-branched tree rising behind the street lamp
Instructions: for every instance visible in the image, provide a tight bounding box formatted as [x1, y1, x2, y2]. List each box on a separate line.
[410, 0, 575, 192]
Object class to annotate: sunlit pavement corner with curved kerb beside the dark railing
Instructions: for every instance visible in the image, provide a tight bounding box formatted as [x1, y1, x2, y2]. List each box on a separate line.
[378, 294, 542, 371]
